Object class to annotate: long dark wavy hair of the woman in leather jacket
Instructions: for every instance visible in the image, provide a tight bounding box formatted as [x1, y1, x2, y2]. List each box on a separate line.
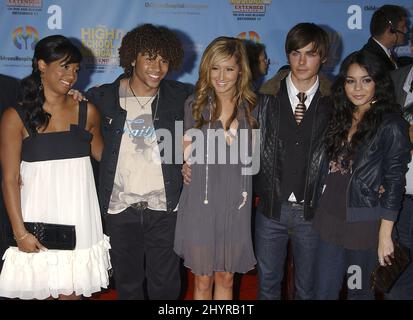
[325, 51, 400, 161]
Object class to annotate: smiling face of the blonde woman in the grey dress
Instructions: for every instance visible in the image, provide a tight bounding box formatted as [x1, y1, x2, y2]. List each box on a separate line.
[210, 56, 240, 98]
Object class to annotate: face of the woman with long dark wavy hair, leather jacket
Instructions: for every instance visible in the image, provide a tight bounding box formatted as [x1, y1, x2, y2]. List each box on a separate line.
[344, 63, 376, 108]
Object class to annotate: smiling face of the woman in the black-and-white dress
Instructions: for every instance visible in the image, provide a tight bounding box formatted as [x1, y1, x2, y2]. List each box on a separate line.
[38, 57, 79, 94]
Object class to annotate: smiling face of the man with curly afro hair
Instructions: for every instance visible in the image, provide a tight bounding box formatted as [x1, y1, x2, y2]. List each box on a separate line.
[132, 53, 169, 96]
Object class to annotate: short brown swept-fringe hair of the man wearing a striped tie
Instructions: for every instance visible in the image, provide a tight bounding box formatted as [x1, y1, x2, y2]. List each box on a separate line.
[285, 22, 330, 61]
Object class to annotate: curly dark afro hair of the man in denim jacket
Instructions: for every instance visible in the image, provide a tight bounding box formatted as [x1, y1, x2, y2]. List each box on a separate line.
[119, 24, 184, 75]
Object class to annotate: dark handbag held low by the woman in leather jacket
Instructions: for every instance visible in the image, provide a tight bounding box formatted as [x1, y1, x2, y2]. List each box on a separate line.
[370, 242, 411, 293]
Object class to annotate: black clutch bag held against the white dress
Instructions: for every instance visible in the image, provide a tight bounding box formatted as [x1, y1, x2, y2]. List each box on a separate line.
[8, 222, 76, 250]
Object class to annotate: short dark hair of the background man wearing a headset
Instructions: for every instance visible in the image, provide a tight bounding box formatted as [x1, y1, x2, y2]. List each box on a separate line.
[370, 4, 408, 37]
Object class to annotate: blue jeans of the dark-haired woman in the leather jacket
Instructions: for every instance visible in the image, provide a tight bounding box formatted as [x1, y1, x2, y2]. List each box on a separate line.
[315, 239, 378, 300]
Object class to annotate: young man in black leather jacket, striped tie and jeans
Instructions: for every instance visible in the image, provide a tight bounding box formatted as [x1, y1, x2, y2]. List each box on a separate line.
[254, 23, 332, 299]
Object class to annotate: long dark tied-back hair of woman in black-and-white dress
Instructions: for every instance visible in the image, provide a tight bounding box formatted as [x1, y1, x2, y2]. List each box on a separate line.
[20, 35, 82, 132]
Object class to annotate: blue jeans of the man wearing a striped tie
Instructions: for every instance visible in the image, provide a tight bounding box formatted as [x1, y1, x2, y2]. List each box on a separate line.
[255, 203, 318, 300]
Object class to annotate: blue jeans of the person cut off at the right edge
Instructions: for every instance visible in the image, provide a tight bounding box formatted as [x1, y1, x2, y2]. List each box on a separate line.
[386, 197, 413, 300]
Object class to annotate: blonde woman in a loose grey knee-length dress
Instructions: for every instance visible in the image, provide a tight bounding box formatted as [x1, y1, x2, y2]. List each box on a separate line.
[174, 37, 259, 300]
